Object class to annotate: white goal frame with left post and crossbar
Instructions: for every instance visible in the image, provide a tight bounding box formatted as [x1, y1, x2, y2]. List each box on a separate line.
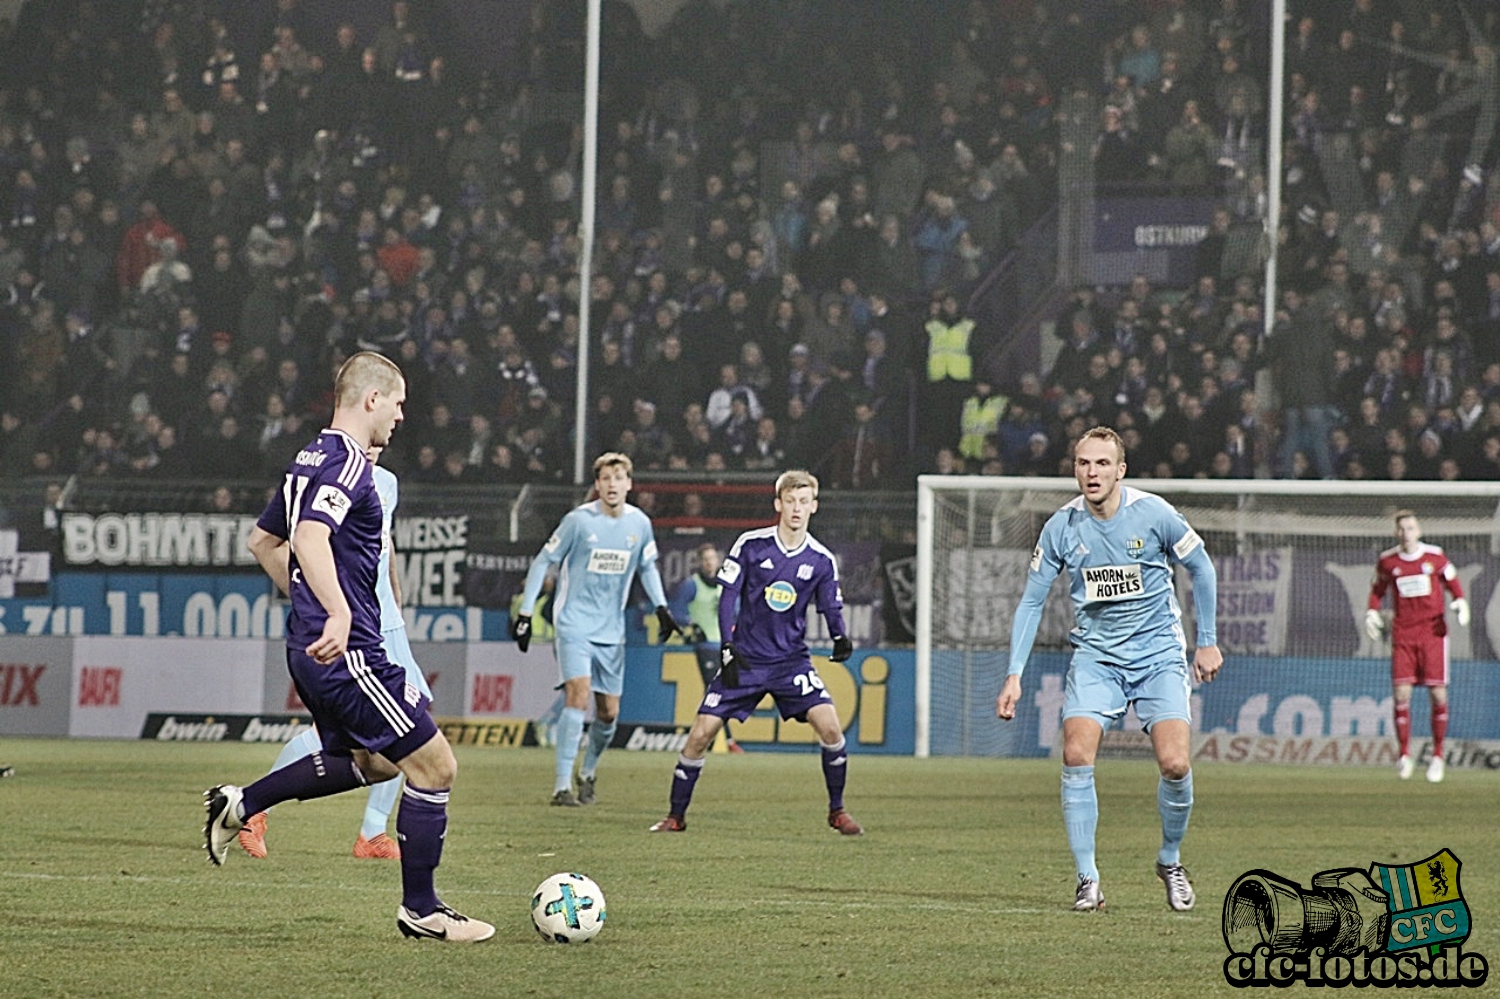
[915, 476, 1500, 758]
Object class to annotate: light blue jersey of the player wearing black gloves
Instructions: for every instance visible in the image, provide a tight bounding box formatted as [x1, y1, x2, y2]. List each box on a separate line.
[521, 500, 666, 645]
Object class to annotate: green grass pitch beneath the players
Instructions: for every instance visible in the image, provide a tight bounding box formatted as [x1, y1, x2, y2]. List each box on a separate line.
[0, 740, 1500, 999]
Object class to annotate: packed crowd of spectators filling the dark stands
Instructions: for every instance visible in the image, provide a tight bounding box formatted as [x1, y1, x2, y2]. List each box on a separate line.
[0, 0, 1500, 504]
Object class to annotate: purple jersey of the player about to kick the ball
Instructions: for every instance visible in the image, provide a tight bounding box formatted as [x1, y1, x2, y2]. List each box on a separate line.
[257, 429, 383, 650]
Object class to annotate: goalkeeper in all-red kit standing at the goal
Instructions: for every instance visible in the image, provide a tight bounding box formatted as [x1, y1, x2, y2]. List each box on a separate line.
[1365, 510, 1469, 785]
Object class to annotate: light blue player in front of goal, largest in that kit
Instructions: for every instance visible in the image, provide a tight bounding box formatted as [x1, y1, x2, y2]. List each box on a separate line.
[996, 426, 1224, 912]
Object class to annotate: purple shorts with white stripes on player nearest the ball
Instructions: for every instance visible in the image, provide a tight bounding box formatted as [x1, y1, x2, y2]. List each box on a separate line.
[287, 645, 438, 762]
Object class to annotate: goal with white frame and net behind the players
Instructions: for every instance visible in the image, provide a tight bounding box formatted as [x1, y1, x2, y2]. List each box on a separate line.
[917, 476, 1500, 756]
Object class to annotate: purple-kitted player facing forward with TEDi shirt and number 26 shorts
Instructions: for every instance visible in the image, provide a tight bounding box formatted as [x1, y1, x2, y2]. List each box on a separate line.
[651, 471, 864, 836]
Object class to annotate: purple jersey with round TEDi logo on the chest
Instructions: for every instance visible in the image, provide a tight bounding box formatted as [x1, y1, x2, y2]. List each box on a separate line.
[719, 527, 845, 663]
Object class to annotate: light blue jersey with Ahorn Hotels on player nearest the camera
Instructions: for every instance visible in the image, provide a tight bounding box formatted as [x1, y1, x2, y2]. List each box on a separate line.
[1010, 486, 1218, 674]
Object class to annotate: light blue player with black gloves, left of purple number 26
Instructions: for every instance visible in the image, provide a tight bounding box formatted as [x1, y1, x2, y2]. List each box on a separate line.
[510, 452, 678, 807]
